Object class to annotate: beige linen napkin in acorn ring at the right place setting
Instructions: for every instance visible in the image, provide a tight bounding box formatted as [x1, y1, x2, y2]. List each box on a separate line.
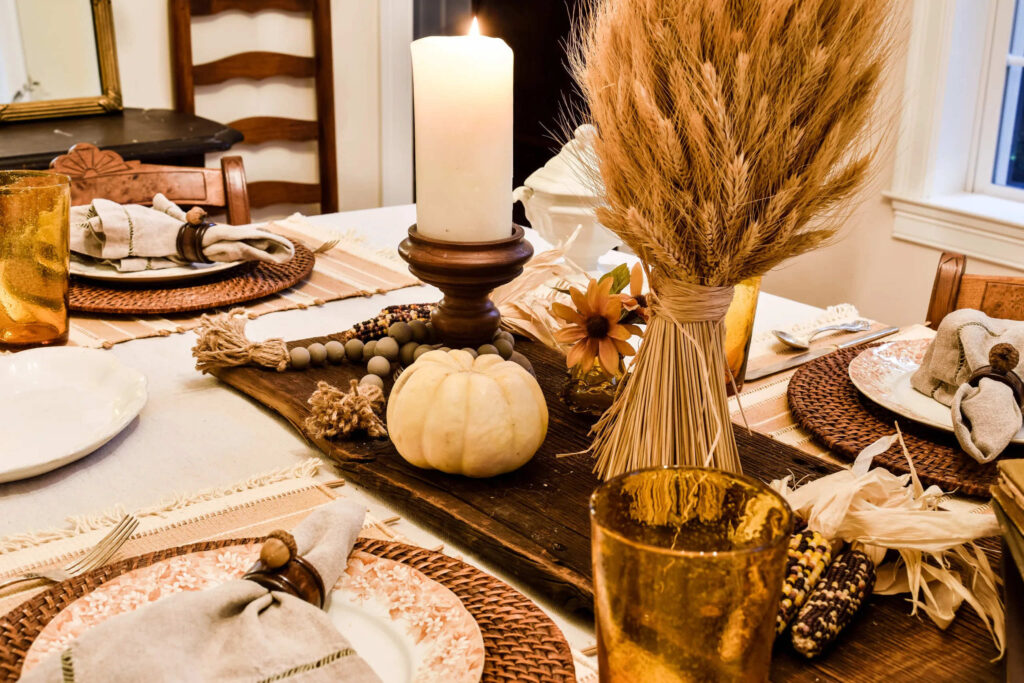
[910, 308, 1024, 463]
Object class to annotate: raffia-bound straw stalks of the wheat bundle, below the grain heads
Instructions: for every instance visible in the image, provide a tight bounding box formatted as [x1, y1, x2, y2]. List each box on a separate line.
[592, 274, 740, 479]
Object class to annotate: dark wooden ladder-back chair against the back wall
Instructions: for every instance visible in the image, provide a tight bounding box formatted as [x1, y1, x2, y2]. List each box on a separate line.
[170, 0, 338, 213]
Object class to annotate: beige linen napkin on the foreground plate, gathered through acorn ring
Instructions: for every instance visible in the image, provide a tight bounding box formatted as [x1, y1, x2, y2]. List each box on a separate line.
[22, 500, 380, 683]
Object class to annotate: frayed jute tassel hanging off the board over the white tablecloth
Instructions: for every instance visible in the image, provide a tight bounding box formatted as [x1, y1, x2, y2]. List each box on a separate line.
[193, 308, 289, 373]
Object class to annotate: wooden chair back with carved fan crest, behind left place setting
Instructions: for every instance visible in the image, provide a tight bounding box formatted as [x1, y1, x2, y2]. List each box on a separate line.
[50, 142, 252, 225]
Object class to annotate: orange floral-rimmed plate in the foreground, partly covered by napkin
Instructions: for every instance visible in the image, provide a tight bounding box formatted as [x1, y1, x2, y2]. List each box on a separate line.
[23, 543, 484, 683]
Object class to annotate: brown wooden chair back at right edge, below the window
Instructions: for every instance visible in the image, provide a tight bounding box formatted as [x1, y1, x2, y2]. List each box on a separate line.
[927, 252, 1024, 329]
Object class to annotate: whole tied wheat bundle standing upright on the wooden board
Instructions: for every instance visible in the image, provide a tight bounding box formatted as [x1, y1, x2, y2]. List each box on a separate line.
[570, 0, 892, 478]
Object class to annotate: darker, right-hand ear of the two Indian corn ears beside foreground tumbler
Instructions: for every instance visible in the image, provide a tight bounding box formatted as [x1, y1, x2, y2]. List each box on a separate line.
[791, 550, 874, 657]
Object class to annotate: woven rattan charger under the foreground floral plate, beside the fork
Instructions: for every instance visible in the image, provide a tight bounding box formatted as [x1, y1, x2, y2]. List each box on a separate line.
[0, 539, 575, 683]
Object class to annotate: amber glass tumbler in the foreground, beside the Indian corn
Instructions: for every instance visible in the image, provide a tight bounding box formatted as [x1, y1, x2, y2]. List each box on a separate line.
[590, 467, 793, 683]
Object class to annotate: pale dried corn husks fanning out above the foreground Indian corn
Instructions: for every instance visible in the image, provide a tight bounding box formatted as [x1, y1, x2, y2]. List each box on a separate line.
[771, 432, 1006, 656]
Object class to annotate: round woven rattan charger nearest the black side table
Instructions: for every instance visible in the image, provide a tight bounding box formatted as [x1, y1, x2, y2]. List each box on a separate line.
[69, 243, 316, 315]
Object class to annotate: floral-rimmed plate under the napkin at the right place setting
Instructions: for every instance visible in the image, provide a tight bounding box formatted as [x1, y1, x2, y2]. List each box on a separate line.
[849, 339, 1024, 443]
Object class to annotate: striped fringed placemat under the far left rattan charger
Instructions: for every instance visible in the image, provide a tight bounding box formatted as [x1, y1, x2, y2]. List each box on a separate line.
[69, 214, 419, 348]
